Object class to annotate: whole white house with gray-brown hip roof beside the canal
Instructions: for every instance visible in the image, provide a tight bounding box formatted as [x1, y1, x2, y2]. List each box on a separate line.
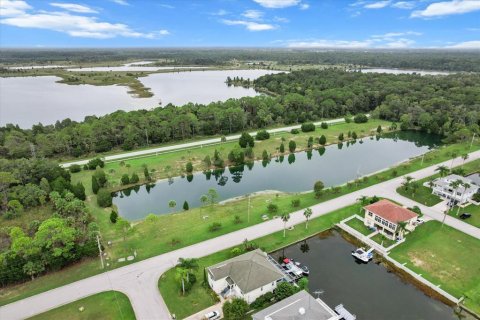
[207, 249, 285, 303]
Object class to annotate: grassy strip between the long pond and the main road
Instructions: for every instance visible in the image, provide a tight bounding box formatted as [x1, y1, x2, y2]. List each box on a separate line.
[0, 139, 480, 305]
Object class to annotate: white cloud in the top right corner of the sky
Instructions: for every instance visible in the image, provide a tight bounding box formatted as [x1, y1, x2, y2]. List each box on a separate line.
[410, 0, 480, 18]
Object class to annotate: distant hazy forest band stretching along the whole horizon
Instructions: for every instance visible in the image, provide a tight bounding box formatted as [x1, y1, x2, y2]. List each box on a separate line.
[0, 48, 480, 72]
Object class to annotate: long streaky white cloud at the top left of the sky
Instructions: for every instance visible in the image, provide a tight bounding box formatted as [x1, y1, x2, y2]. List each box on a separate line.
[0, 0, 169, 39]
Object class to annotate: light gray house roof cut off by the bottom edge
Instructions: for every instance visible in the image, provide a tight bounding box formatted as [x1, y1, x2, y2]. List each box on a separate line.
[252, 290, 342, 320]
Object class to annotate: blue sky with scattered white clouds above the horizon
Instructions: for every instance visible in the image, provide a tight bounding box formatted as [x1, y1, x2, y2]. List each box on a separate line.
[0, 0, 480, 49]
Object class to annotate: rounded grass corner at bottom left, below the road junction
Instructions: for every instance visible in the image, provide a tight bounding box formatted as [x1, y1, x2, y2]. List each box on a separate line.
[29, 291, 135, 320]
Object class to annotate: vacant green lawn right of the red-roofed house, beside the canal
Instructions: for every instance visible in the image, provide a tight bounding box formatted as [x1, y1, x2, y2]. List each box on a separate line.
[390, 221, 480, 313]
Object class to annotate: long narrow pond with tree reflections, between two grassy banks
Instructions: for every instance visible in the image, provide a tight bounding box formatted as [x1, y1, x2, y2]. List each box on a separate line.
[113, 132, 439, 220]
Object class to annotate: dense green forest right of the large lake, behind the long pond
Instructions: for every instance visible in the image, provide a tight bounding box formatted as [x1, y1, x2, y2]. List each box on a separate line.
[255, 69, 480, 142]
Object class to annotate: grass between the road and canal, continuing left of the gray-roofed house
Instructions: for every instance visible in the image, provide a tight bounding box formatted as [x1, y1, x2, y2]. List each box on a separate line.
[158, 205, 360, 319]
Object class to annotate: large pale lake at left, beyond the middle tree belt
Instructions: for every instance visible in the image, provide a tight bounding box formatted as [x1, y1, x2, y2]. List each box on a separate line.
[0, 70, 282, 128]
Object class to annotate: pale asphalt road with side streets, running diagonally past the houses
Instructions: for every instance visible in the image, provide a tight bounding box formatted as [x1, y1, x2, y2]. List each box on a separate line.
[0, 151, 480, 320]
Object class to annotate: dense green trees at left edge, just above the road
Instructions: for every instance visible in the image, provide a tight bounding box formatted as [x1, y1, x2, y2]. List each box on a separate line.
[0, 159, 98, 286]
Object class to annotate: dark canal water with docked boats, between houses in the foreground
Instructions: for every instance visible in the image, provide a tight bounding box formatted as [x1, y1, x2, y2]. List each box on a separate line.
[273, 232, 458, 320]
